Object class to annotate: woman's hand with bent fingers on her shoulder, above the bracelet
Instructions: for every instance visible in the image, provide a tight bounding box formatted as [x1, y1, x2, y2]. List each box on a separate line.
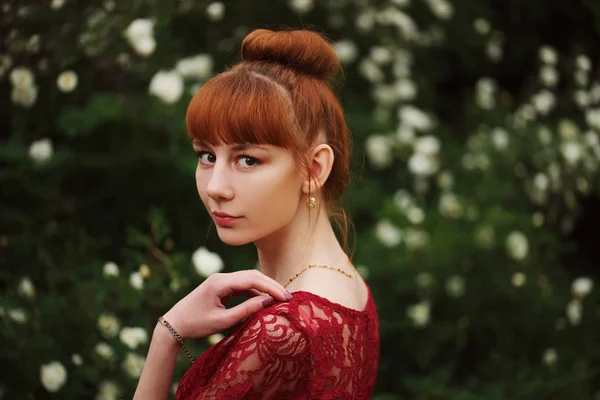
[158, 270, 292, 339]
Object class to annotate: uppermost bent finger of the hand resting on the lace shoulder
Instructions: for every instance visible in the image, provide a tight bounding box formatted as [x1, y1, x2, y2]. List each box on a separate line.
[217, 270, 289, 301]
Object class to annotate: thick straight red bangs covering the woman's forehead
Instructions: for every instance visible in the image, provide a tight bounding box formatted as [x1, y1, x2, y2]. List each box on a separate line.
[186, 71, 298, 148]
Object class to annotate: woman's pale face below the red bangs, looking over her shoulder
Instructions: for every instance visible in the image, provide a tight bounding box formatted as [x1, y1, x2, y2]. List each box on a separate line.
[193, 141, 303, 246]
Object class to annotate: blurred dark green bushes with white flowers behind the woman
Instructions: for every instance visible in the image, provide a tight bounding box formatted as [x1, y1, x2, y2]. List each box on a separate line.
[0, 0, 600, 400]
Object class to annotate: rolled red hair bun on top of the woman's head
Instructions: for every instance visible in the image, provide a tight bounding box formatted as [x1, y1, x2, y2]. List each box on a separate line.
[241, 29, 340, 80]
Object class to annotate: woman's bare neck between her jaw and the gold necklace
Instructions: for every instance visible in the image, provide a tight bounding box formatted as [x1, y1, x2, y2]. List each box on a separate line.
[254, 206, 350, 285]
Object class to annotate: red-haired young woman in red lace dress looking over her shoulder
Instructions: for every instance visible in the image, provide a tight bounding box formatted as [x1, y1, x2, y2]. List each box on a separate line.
[135, 30, 379, 399]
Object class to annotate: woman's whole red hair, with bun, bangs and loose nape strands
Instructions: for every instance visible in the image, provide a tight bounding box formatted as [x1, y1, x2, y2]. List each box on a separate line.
[186, 29, 351, 253]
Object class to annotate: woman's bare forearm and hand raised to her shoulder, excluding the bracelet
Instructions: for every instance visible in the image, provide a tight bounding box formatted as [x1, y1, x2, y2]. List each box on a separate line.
[134, 270, 291, 400]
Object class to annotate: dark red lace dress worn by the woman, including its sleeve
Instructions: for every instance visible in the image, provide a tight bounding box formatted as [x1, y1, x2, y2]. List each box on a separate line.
[175, 286, 379, 400]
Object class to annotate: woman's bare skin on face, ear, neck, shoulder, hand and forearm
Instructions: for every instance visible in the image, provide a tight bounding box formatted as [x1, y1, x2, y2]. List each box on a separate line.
[134, 142, 358, 399]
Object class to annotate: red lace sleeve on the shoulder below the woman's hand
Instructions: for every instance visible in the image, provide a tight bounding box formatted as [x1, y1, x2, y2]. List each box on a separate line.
[198, 307, 310, 400]
